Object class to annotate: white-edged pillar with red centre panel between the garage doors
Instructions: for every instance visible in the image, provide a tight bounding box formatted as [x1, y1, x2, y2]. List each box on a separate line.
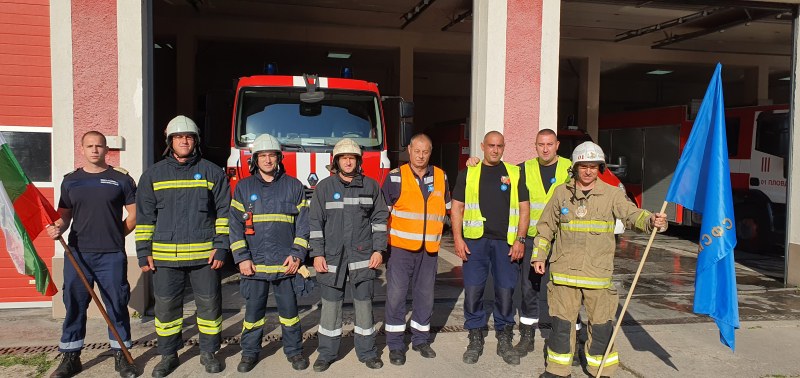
[470, 0, 561, 163]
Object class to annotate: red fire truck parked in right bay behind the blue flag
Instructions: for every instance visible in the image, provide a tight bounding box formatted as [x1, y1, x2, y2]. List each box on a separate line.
[599, 105, 789, 249]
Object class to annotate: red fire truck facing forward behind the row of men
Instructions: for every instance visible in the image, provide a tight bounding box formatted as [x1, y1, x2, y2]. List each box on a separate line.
[227, 75, 413, 195]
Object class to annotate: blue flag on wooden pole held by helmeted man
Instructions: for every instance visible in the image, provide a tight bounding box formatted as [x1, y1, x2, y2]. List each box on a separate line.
[666, 63, 739, 350]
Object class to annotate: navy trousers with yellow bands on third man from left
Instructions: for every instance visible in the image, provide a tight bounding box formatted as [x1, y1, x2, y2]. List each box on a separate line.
[239, 277, 303, 358]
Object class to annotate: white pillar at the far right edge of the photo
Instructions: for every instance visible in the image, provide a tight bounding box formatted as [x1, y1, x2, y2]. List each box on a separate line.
[784, 12, 800, 286]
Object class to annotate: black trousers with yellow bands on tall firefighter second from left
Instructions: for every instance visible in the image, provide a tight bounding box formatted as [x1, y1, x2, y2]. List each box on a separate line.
[153, 264, 222, 355]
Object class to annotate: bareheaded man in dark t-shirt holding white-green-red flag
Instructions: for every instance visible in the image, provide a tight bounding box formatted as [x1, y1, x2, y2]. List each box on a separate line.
[47, 131, 136, 377]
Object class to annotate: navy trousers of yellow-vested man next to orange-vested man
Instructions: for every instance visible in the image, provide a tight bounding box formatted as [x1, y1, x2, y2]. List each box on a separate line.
[463, 238, 520, 331]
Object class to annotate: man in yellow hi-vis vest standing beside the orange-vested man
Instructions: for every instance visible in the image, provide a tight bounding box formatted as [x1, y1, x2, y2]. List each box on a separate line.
[450, 131, 529, 365]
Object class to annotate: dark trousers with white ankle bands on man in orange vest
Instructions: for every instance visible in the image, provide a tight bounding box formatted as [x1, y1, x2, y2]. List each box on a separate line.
[384, 247, 439, 350]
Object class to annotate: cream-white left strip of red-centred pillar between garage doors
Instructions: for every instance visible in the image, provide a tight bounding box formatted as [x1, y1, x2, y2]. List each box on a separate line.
[469, 0, 508, 157]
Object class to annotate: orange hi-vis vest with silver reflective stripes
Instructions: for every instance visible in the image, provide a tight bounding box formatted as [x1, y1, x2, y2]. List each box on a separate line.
[389, 164, 447, 253]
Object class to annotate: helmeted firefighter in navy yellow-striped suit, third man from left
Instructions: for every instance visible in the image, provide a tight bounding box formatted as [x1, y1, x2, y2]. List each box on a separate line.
[230, 134, 308, 373]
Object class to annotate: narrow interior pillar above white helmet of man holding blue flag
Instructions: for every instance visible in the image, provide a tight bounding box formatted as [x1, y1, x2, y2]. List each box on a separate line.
[578, 57, 600, 140]
